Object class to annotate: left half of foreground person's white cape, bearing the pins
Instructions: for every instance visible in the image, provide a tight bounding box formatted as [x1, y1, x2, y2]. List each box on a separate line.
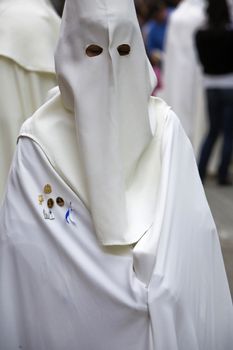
[0, 139, 151, 350]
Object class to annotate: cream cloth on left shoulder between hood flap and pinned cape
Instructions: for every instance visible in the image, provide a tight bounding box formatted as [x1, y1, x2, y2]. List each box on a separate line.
[19, 88, 87, 203]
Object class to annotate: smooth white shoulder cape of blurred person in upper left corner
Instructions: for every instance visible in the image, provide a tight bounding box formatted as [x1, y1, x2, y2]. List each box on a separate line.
[0, 0, 60, 73]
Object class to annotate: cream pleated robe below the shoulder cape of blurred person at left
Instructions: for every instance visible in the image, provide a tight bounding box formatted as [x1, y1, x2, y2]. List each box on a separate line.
[0, 56, 56, 202]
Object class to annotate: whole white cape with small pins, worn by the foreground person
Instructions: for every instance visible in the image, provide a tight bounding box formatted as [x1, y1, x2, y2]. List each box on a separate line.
[0, 94, 233, 350]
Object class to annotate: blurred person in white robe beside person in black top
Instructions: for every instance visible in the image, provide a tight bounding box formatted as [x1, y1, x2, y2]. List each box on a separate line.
[161, 0, 206, 154]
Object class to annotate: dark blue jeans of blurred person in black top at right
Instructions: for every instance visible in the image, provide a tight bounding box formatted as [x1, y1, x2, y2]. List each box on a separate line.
[198, 88, 233, 184]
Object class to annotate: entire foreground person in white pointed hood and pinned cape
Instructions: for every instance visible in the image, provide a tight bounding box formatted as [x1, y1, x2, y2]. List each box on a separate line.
[0, 0, 233, 350]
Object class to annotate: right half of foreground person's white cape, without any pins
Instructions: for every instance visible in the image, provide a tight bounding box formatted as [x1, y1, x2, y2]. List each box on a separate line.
[148, 112, 233, 350]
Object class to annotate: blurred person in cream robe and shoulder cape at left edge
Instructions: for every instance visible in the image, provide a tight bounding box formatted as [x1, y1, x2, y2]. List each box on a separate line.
[0, 0, 60, 202]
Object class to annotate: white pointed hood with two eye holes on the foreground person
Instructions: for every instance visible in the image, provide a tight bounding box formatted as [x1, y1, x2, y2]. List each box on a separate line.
[55, 0, 158, 245]
